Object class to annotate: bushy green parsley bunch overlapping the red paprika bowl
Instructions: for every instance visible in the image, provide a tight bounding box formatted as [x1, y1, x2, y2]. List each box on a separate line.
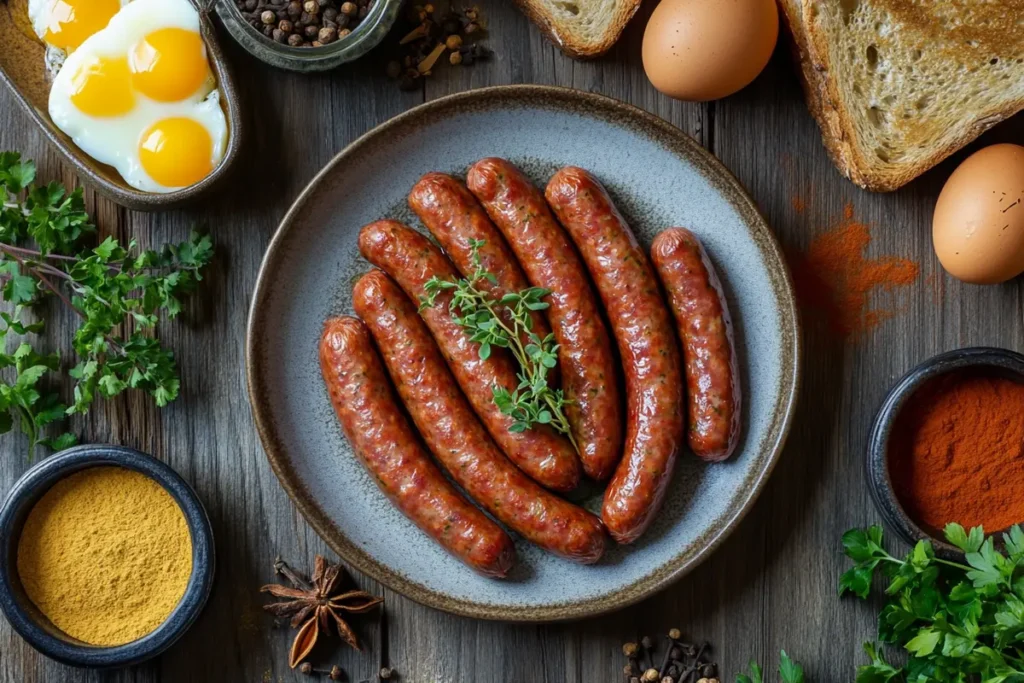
[839, 524, 1024, 683]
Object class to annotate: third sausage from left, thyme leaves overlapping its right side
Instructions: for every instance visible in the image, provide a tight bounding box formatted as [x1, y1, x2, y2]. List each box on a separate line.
[359, 220, 580, 490]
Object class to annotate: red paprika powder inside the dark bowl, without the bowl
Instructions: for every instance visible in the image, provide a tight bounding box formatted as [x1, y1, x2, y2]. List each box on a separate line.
[889, 372, 1024, 532]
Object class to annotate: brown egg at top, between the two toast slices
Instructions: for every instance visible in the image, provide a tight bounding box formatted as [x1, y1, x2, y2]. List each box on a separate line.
[643, 0, 778, 101]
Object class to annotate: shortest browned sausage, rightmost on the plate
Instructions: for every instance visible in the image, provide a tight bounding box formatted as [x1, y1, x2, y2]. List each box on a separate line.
[650, 227, 740, 462]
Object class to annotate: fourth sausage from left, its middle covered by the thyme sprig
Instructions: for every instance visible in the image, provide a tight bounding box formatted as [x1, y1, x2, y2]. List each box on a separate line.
[409, 173, 554, 362]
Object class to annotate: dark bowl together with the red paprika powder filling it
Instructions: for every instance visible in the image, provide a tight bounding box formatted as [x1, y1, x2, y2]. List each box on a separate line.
[867, 347, 1024, 556]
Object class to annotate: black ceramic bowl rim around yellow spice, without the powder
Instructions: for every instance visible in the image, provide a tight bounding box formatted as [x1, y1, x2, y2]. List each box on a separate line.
[0, 445, 215, 668]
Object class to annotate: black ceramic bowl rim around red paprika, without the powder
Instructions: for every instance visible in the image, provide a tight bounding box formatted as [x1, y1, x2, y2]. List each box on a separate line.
[867, 346, 1024, 558]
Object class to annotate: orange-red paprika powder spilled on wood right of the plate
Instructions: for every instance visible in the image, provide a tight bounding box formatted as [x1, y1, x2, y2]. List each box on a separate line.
[790, 202, 921, 338]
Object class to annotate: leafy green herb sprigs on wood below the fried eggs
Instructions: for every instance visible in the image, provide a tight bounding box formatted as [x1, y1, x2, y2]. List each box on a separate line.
[0, 152, 213, 458]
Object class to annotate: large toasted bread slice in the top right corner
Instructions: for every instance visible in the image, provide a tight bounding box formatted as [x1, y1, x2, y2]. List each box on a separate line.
[779, 0, 1024, 190]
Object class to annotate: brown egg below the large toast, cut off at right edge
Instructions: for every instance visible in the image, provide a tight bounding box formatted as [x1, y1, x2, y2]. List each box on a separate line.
[932, 144, 1024, 285]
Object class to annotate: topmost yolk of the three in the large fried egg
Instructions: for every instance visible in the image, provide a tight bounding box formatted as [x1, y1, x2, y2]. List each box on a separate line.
[129, 29, 210, 102]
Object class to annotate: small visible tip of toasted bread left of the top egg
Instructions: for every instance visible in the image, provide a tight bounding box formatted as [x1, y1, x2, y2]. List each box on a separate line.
[516, 0, 640, 58]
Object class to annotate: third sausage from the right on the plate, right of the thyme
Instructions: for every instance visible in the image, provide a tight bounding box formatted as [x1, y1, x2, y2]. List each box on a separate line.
[466, 159, 623, 481]
